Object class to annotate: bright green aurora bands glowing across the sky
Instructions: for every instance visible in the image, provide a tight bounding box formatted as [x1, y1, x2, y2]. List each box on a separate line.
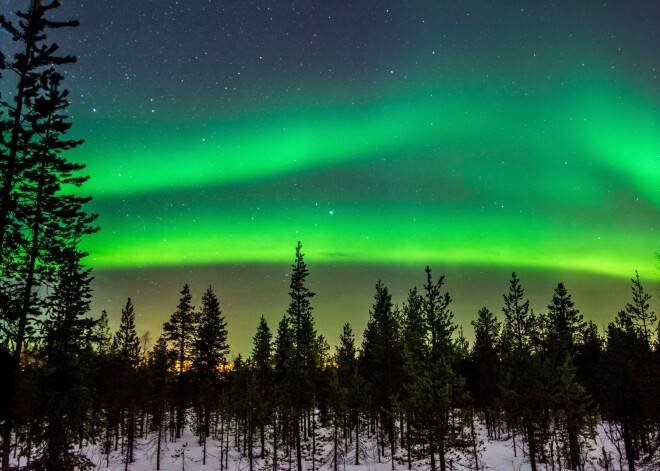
[83, 76, 660, 277]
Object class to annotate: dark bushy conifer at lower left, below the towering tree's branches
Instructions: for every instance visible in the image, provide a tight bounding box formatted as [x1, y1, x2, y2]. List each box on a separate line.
[31, 241, 95, 471]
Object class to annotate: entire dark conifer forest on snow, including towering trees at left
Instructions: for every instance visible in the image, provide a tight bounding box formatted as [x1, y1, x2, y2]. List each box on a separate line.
[0, 1, 660, 471]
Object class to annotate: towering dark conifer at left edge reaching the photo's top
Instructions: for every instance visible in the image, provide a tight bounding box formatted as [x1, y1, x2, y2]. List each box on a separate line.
[0, 0, 86, 470]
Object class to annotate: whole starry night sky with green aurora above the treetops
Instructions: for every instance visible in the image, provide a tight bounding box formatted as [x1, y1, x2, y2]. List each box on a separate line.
[0, 0, 660, 353]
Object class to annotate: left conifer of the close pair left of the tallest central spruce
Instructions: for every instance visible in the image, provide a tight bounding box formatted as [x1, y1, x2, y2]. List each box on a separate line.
[163, 285, 198, 438]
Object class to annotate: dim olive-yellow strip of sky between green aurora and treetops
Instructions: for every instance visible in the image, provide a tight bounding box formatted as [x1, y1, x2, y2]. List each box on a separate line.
[92, 260, 658, 359]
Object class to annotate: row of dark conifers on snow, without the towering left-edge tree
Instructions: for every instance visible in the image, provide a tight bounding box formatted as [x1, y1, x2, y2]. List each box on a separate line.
[3, 243, 660, 470]
